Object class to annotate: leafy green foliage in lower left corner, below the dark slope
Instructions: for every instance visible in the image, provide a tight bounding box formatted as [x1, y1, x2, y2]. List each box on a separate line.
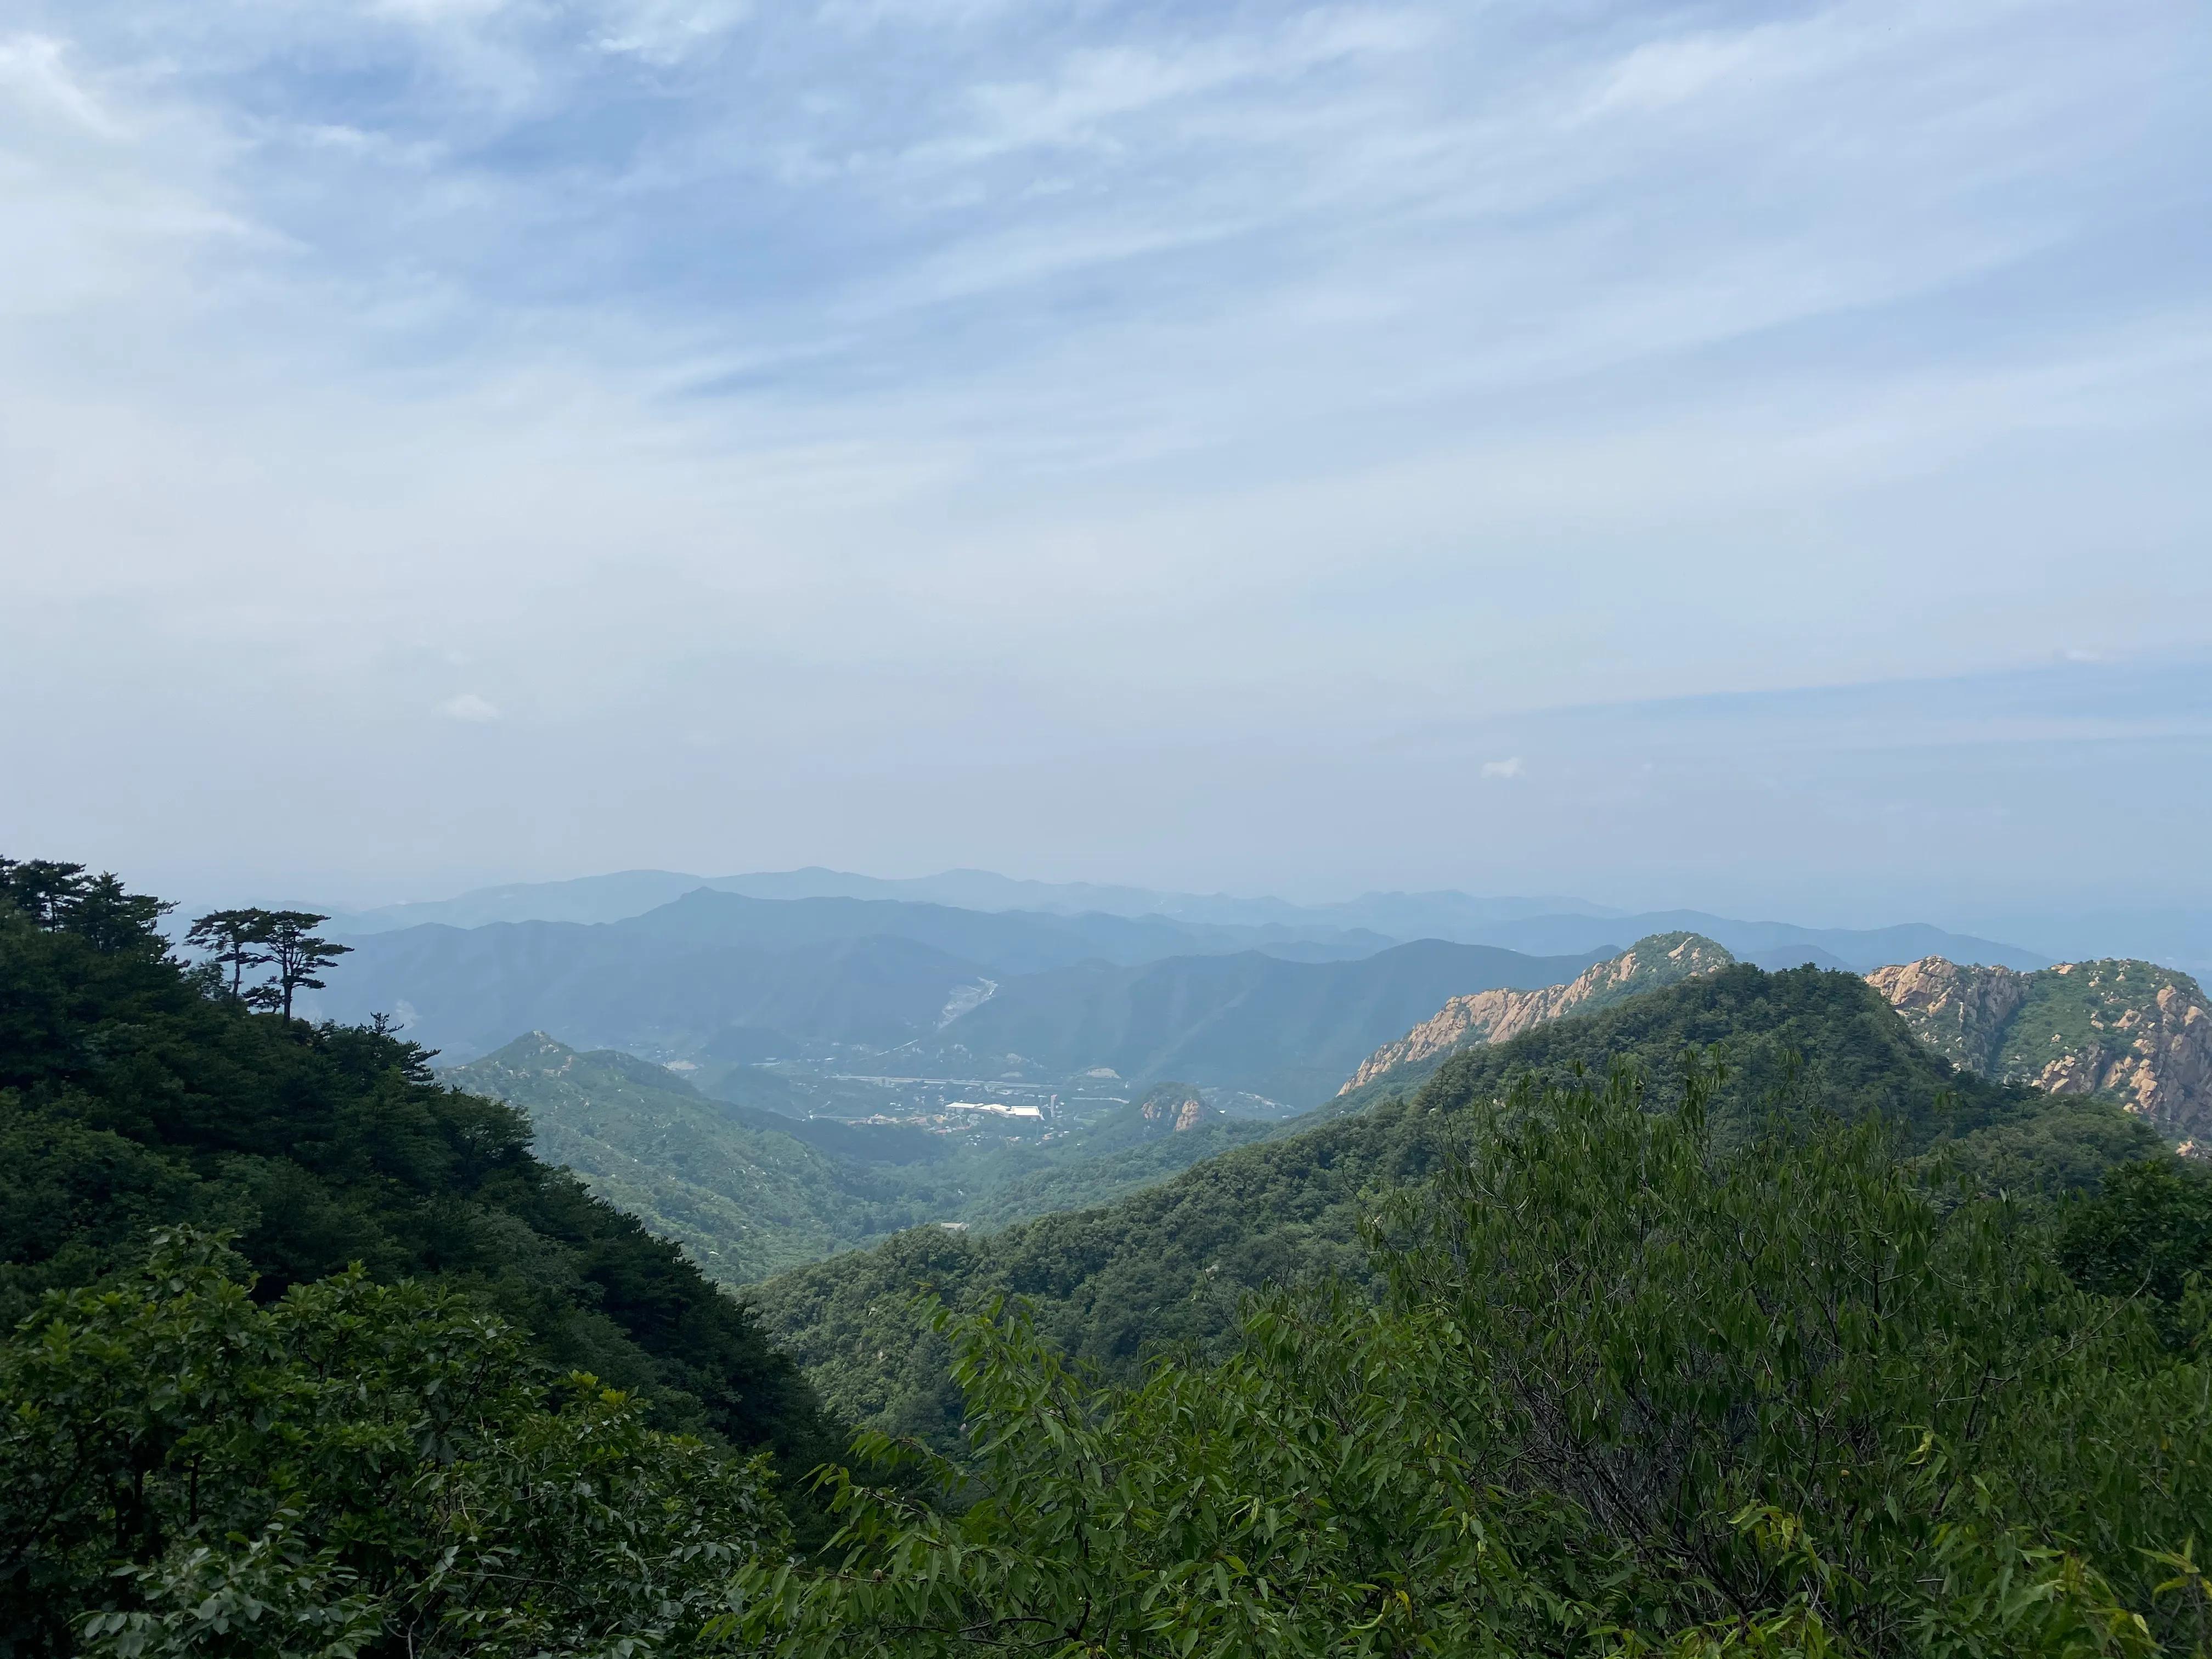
[0, 1230, 778, 1659]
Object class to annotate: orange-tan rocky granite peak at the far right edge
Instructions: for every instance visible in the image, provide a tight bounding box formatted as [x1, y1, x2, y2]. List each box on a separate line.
[1867, 956, 2212, 1150]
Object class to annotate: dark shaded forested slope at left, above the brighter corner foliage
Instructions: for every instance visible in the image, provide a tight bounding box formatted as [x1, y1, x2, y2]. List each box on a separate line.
[0, 862, 834, 1469]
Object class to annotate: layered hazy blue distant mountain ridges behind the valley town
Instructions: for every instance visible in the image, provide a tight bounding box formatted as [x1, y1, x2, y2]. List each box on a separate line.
[314, 870, 2044, 1115]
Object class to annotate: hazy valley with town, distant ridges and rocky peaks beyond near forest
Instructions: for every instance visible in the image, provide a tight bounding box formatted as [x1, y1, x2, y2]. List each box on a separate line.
[303, 872, 2212, 1327]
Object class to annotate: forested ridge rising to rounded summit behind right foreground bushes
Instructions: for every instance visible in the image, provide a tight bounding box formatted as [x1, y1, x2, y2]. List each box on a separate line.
[750, 967, 2159, 1436]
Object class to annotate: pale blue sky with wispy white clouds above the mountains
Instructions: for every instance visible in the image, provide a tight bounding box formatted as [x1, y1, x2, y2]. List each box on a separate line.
[0, 0, 2212, 949]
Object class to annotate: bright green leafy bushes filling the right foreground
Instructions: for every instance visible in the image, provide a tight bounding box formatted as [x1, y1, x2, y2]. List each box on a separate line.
[714, 1073, 2212, 1659]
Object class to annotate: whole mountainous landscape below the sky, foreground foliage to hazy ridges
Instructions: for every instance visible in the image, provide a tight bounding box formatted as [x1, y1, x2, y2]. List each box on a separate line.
[0, 860, 2212, 1659]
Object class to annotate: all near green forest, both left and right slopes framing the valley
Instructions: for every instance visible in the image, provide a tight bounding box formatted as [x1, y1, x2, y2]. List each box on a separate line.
[0, 862, 2212, 1659]
